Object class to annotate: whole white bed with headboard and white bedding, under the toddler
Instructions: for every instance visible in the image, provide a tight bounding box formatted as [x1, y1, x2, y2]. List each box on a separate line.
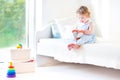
[36, 19, 120, 69]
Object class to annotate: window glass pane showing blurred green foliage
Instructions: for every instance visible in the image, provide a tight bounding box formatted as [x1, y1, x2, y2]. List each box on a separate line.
[0, 0, 26, 48]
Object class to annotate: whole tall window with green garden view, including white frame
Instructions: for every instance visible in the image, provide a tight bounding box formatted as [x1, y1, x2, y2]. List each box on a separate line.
[0, 0, 35, 61]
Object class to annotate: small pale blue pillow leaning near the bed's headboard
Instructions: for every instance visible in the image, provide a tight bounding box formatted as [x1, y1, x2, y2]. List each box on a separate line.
[50, 21, 61, 38]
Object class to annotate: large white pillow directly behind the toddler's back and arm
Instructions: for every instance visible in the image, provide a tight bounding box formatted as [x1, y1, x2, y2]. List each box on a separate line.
[55, 18, 76, 39]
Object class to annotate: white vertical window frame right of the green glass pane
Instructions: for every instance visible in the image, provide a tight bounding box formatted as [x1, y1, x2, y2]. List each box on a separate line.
[26, 0, 35, 57]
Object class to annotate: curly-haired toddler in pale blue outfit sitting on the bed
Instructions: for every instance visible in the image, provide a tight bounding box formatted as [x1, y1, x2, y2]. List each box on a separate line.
[68, 6, 95, 50]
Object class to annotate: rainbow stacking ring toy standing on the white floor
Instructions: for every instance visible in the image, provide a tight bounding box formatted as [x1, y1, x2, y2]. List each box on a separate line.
[7, 62, 16, 78]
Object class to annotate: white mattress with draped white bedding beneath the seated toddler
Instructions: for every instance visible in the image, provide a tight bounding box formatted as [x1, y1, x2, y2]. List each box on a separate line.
[37, 39, 120, 69]
